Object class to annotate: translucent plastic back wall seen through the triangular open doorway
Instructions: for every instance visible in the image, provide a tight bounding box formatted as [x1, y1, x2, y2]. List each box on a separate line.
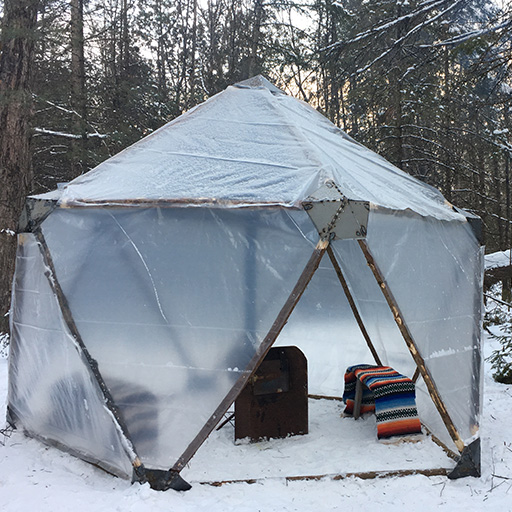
[277, 236, 416, 397]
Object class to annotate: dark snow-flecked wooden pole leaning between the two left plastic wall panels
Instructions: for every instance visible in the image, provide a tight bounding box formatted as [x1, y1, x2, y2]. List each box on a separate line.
[34, 228, 142, 468]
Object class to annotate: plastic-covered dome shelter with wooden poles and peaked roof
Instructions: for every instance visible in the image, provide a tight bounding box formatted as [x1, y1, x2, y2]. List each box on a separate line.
[8, 77, 483, 489]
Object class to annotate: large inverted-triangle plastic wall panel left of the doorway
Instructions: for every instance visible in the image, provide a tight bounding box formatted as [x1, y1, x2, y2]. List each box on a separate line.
[42, 208, 314, 469]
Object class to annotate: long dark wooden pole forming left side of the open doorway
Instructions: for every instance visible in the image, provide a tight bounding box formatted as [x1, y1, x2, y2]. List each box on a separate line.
[172, 240, 329, 471]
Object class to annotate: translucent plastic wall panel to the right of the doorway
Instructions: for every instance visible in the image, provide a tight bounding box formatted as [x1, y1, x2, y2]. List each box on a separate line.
[368, 210, 483, 442]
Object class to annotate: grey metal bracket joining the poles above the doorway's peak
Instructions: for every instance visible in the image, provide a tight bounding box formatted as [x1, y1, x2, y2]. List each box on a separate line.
[302, 180, 370, 241]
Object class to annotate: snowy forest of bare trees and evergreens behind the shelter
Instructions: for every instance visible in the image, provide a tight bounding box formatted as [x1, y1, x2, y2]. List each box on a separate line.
[0, 0, 512, 333]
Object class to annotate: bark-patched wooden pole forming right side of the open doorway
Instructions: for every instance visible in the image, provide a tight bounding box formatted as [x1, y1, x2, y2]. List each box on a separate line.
[358, 240, 464, 453]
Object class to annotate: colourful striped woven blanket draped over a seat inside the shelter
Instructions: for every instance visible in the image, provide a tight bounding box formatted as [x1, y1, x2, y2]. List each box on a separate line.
[343, 364, 421, 439]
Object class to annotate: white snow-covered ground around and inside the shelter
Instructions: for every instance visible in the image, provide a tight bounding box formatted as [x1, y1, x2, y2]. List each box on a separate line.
[0, 334, 512, 512]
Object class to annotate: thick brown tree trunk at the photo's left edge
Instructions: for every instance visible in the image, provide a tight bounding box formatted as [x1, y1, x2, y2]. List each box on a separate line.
[0, 0, 39, 332]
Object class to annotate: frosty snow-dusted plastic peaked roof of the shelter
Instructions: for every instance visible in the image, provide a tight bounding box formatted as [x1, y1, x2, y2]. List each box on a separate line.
[54, 76, 463, 219]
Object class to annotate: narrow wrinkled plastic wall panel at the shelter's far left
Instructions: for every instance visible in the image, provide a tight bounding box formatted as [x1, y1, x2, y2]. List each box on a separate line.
[8, 234, 131, 477]
